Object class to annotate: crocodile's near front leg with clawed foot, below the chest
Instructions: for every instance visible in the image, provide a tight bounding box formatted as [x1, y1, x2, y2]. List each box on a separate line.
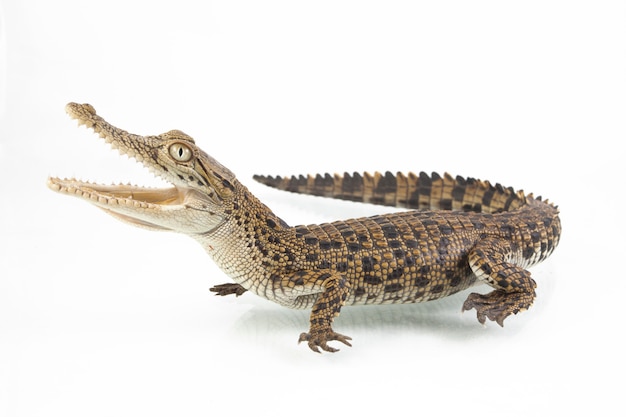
[285, 270, 352, 353]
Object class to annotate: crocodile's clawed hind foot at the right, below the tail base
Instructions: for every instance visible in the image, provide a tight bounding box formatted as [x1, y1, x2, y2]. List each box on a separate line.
[463, 290, 533, 326]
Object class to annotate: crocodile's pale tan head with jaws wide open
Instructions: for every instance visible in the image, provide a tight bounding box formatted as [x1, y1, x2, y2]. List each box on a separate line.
[48, 103, 237, 234]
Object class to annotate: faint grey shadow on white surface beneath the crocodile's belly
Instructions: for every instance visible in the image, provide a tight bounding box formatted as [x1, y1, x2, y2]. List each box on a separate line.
[224, 286, 523, 350]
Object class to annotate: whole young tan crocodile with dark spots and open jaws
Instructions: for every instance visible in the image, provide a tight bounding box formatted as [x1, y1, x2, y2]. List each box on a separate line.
[49, 103, 561, 351]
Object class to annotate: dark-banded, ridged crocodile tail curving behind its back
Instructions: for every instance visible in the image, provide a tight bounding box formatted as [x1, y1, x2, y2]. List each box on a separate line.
[254, 171, 532, 213]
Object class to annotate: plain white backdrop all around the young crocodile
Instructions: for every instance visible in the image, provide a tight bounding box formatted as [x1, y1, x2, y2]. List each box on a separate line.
[0, 0, 626, 417]
